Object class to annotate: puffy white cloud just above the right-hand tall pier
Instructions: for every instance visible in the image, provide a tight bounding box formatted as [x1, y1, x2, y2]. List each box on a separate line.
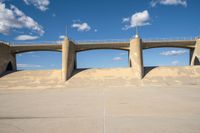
[122, 10, 150, 30]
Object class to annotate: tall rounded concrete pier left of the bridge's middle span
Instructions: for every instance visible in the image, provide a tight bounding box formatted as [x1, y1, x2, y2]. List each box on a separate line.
[62, 38, 76, 81]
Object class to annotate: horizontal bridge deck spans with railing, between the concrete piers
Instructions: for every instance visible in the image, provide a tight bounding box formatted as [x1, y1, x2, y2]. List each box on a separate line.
[11, 40, 196, 54]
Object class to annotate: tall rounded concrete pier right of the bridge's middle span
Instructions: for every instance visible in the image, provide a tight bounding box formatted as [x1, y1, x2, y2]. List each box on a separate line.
[129, 36, 144, 79]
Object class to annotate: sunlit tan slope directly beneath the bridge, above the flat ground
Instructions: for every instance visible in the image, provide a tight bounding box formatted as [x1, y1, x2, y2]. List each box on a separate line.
[0, 66, 200, 89]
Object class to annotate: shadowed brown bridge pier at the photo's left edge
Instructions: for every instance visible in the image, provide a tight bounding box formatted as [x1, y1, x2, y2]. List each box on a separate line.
[0, 43, 17, 75]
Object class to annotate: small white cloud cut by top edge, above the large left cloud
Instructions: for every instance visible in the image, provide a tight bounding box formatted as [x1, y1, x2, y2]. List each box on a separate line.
[23, 0, 50, 11]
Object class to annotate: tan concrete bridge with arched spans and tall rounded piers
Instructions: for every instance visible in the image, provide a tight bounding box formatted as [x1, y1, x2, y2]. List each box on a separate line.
[0, 36, 200, 81]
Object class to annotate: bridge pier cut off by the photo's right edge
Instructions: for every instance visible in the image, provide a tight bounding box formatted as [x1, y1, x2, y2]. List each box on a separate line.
[191, 39, 200, 66]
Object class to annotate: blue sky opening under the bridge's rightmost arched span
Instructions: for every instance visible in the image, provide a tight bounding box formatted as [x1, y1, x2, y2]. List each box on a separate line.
[143, 47, 191, 67]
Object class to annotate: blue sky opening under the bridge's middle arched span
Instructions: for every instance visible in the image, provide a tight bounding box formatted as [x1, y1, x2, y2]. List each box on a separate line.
[76, 49, 129, 69]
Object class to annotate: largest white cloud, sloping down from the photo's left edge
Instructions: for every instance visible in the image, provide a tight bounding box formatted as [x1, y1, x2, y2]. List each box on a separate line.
[0, 2, 44, 35]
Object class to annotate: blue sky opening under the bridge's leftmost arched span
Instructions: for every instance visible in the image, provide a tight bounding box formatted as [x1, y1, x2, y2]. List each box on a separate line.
[16, 51, 62, 70]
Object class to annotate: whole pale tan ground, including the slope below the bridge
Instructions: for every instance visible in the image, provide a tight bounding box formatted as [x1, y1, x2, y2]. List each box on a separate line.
[0, 66, 200, 133]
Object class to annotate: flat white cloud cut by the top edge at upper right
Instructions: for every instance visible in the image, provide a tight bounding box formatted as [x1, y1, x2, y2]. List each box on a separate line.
[151, 0, 187, 7]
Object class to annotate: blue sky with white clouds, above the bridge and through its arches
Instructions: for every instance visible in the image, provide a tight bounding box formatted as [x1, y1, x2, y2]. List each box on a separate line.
[0, 0, 200, 69]
